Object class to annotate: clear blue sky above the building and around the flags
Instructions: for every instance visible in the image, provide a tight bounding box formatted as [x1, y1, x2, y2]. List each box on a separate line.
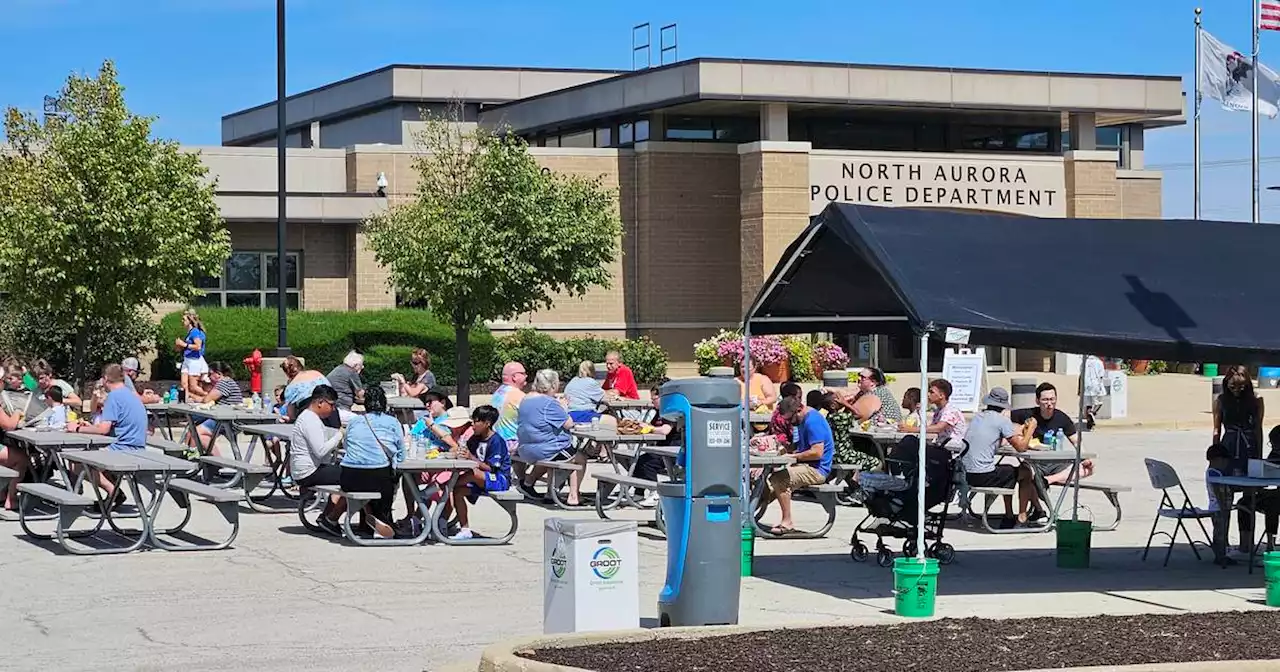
[0, 0, 1280, 221]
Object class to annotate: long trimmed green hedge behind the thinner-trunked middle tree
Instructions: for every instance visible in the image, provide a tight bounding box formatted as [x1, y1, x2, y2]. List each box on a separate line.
[152, 308, 495, 385]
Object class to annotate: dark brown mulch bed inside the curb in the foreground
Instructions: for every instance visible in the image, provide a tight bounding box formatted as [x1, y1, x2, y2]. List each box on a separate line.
[520, 611, 1280, 672]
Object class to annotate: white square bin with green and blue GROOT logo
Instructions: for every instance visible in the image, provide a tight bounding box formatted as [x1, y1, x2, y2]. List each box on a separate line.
[543, 518, 640, 634]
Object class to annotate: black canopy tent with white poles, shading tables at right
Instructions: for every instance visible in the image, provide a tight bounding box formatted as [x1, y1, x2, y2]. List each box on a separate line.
[742, 204, 1280, 553]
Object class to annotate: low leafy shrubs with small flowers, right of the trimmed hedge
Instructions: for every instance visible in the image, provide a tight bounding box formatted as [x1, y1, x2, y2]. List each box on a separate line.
[494, 329, 667, 385]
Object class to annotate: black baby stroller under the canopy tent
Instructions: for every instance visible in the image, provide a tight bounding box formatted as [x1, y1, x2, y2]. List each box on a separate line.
[849, 436, 969, 567]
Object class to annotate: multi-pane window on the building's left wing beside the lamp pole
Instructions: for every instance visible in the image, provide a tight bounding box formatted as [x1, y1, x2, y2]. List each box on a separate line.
[195, 251, 301, 308]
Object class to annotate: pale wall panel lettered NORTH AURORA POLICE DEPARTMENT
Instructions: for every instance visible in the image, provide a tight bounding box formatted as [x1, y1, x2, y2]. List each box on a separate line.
[809, 152, 1066, 218]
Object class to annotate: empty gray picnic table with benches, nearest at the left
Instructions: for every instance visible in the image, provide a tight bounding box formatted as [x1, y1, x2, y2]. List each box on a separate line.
[19, 451, 220, 556]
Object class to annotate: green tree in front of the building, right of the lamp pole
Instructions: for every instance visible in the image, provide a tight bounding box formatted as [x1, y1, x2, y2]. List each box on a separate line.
[364, 106, 622, 404]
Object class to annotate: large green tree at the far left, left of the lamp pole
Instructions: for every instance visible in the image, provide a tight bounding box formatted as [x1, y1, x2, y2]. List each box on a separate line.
[0, 61, 230, 381]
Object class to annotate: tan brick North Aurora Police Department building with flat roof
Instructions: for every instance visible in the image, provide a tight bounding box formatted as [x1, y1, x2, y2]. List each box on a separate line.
[201, 59, 1185, 370]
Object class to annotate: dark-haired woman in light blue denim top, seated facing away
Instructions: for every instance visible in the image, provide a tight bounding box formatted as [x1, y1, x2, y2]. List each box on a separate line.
[339, 385, 404, 538]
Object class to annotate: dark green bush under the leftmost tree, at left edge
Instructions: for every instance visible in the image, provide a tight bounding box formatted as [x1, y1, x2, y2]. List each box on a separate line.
[0, 304, 157, 380]
